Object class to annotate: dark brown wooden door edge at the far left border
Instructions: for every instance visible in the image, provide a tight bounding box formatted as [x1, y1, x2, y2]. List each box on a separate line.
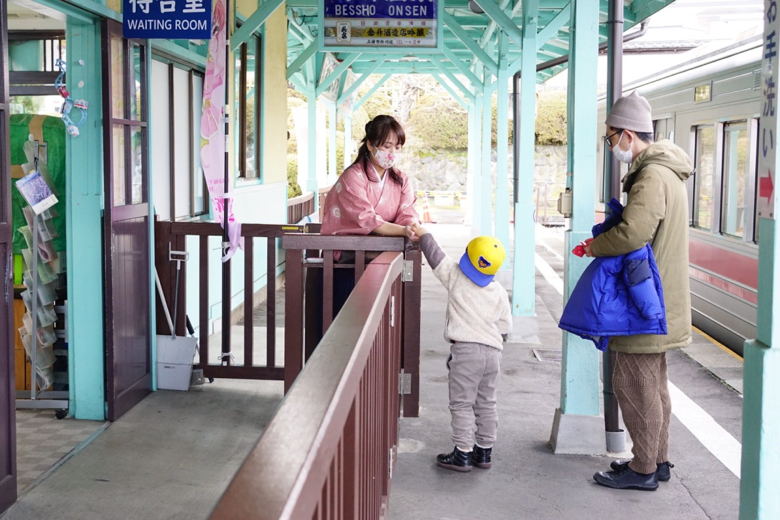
[0, 0, 16, 513]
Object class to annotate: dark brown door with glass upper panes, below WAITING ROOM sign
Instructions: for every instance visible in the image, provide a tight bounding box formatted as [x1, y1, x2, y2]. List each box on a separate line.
[103, 20, 152, 421]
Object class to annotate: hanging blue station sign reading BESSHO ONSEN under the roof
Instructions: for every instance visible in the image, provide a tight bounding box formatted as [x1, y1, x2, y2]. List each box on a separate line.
[320, 0, 441, 50]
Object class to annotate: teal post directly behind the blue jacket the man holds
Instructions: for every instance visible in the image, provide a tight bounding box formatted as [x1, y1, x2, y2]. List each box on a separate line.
[560, 2, 600, 416]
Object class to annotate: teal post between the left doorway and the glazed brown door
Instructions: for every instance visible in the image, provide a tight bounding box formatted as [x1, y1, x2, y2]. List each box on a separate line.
[63, 16, 106, 421]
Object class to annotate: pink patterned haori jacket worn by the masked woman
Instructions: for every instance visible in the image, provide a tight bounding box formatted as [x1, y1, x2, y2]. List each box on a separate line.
[322, 163, 419, 235]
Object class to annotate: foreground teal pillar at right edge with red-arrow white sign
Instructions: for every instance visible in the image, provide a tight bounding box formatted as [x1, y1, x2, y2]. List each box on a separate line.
[739, 0, 780, 520]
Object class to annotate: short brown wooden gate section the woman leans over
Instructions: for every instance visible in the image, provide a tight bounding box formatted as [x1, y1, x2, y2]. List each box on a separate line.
[282, 233, 422, 417]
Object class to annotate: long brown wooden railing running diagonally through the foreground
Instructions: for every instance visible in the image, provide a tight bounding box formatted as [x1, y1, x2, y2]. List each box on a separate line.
[211, 251, 406, 520]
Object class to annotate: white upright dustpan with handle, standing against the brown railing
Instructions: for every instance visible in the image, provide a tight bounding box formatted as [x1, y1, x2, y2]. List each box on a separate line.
[154, 268, 198, 391]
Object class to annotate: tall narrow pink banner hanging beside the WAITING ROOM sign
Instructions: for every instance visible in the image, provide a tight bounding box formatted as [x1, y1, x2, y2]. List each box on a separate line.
[200, 0, 243, 262]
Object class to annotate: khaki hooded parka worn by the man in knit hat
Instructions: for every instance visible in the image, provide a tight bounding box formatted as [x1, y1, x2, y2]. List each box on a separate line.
[591, 140, 693, 354]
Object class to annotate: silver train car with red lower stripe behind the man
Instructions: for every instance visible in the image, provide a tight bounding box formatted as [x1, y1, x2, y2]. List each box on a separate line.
[598, 34, 763, 355]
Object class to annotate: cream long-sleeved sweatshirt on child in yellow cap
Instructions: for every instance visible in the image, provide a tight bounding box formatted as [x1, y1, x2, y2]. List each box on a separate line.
[420, 233, 512, 350]
